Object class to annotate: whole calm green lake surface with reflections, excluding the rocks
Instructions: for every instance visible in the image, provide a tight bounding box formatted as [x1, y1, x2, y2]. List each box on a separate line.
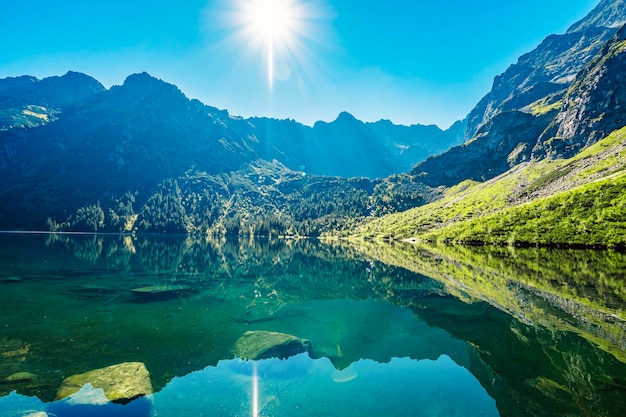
[0, 234, 626, 417]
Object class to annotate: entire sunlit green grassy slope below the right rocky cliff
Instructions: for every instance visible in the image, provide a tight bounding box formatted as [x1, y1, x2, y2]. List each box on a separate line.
[355, 128, 626, 247]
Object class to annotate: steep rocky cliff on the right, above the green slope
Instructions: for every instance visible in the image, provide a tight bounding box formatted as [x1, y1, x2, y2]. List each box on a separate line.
[404, 0, 626, 187]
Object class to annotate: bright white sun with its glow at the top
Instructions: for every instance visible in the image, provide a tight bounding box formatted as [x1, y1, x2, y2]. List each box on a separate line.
[206, 0, 332, 92]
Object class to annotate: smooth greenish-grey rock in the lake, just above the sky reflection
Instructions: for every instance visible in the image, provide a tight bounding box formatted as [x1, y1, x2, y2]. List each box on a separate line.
[233, 330, 312, 360]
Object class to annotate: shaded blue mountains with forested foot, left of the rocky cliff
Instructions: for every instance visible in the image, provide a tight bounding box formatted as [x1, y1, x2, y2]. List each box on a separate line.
[0, 73, 450, 232]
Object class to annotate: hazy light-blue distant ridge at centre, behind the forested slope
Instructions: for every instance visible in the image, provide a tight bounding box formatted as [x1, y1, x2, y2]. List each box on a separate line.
[249, 112, 465, 178]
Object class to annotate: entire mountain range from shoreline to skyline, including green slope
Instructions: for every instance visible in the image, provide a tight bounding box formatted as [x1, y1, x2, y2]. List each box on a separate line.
[0, 0, 626, 246]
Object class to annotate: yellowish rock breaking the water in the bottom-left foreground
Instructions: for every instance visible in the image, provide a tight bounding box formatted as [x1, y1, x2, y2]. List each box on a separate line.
[56, 362, 152, 404]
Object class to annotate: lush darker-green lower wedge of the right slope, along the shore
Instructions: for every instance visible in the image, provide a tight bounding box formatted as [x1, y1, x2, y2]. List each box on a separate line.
[421, 173, 626, 248]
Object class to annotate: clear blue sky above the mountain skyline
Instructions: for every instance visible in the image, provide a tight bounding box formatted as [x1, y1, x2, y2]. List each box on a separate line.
[0, 0, 599, 128]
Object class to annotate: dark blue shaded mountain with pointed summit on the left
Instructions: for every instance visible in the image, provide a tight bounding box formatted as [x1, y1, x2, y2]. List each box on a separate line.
[0, 74, 264, 228]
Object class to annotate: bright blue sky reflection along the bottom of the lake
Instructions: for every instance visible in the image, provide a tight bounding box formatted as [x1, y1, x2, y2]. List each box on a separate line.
[0, 354, 499, 417]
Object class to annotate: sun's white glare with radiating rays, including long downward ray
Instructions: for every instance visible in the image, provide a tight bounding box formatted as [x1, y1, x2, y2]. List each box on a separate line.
[205, 0, 336, 105]
